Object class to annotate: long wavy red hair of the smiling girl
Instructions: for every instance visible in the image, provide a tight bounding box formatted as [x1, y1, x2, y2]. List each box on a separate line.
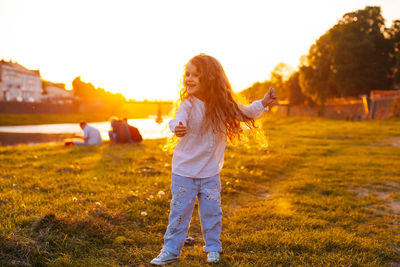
[180, 54, 255, 141]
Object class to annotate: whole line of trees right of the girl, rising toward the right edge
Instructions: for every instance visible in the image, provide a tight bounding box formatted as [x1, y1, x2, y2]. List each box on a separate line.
[241, 6, 400, 110]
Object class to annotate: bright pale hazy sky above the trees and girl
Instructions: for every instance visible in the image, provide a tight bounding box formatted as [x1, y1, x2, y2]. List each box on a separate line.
[0, 0, 400, 100]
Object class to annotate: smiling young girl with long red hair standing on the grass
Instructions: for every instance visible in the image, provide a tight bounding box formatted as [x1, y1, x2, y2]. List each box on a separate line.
[151, 54, 276, 265]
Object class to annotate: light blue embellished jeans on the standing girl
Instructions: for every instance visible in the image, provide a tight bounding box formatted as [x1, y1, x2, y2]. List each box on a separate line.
[163, 174, 222, 255]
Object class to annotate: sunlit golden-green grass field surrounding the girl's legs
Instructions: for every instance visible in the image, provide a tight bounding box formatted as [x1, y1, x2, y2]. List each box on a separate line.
[0, 117, 400, 266]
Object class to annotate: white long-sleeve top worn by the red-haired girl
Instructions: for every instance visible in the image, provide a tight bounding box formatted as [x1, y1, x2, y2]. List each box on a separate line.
[169, 96, 265, 178]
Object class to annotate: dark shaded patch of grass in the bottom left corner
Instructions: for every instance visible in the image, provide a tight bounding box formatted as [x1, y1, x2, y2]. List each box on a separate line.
[0, 214, 113, 266]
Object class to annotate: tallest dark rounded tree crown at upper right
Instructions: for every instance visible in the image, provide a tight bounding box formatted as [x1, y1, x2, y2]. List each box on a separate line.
[299, 7, 394, 105]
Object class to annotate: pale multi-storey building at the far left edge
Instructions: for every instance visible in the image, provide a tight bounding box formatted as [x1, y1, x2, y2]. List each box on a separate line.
[0, 60, 42, 102]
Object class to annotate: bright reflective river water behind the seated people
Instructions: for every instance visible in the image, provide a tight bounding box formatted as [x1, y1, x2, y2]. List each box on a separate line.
[0, 118, 171, 140]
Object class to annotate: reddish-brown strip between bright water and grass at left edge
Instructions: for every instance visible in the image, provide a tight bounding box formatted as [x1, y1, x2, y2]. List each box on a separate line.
[0, 133, 79, 146]
